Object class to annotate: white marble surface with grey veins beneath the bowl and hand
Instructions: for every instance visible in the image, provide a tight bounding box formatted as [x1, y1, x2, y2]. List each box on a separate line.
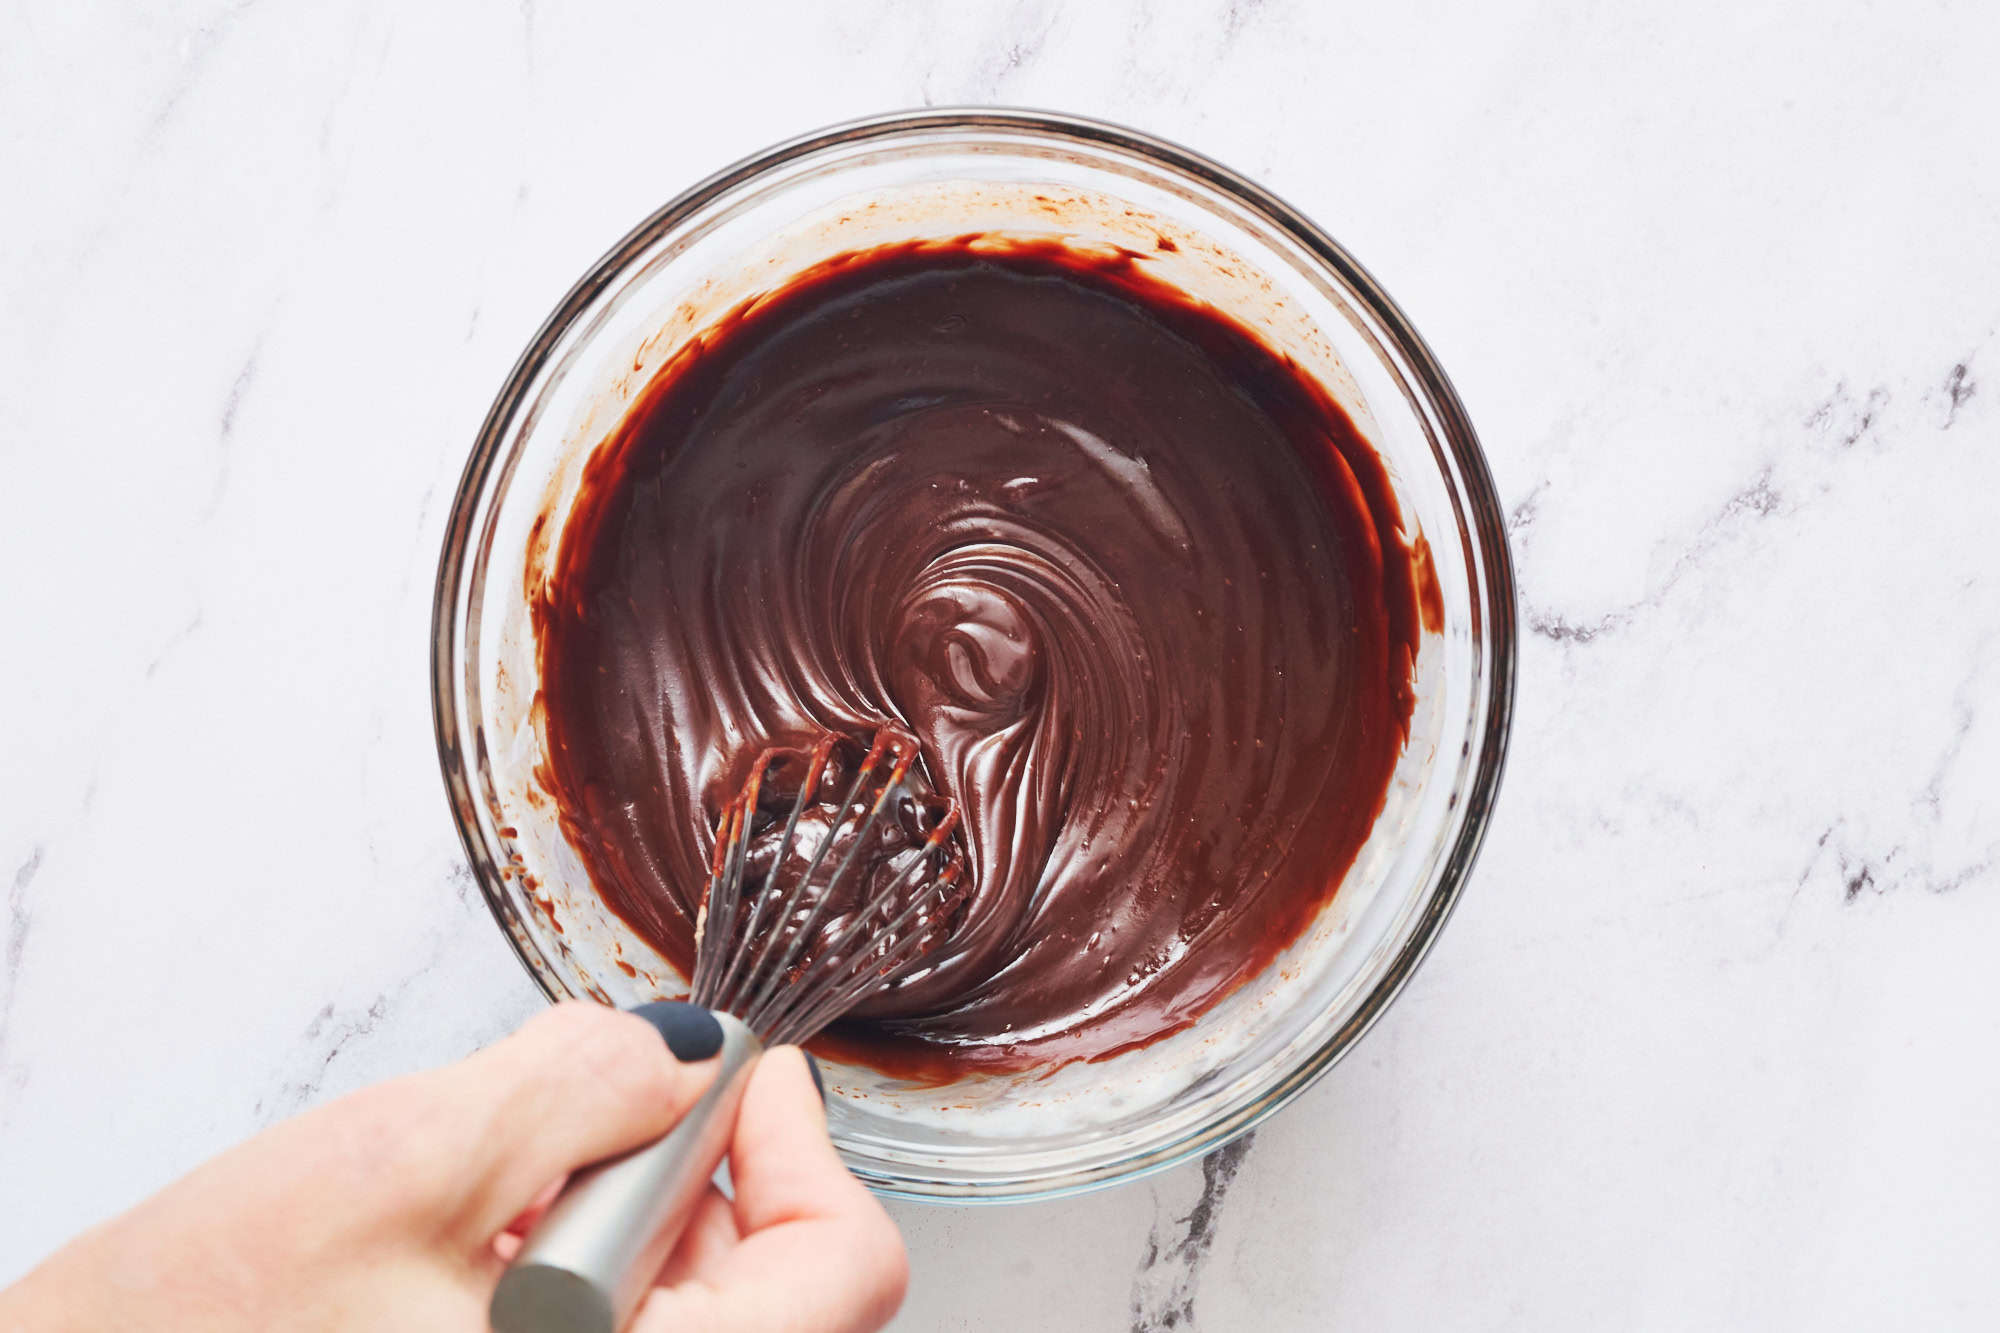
[0, 0, 2000, 1333]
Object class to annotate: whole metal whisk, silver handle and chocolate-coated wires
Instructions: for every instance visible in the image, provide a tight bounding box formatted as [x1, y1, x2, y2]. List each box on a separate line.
[490, 729, 964, 1333]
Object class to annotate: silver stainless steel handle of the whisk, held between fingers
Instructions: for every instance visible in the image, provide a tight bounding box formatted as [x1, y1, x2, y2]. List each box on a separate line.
[490, 1013, 764, 1333]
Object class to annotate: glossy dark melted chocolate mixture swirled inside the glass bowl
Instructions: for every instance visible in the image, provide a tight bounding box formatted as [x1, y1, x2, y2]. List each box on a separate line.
[536, 236, 1422, 1079]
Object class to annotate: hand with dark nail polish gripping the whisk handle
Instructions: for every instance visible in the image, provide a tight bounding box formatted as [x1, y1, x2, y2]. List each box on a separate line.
[0, 1003, 906, 1333]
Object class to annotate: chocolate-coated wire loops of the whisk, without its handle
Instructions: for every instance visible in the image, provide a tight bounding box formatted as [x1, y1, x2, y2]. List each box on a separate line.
[690, 729, 966, 1045]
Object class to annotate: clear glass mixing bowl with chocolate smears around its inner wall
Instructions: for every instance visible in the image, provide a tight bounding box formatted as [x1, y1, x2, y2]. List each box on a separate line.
[432, 110, 1514, 1201]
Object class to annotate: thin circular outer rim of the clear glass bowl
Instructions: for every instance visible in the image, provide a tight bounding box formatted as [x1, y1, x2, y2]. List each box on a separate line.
[430, 106, 1518, 1203]
